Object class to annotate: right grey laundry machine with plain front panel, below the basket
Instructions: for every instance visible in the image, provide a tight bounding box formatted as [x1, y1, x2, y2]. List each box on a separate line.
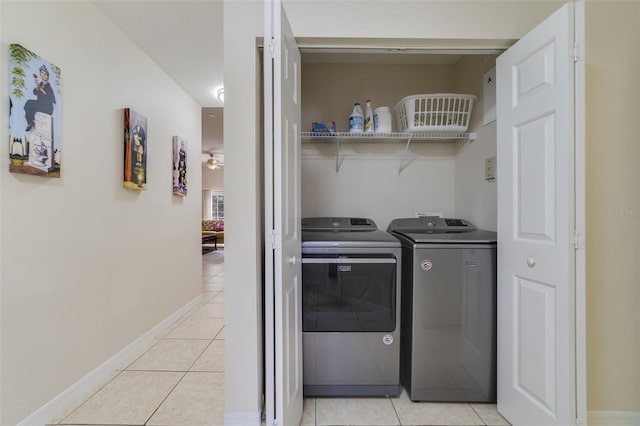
[387, 217, 497, 402]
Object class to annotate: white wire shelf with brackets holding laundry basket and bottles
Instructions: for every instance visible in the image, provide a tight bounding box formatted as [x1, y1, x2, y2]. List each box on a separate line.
[300, 132, 476, 174]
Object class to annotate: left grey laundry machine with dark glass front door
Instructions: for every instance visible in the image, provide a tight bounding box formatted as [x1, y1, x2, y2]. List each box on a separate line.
[302, 217, 401, 396]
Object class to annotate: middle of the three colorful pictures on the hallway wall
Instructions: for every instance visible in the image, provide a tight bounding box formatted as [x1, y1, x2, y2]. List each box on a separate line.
[123, 108, 147, 191]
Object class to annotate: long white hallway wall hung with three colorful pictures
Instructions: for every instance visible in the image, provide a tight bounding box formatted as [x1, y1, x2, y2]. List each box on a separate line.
[0, 1, 202, 425]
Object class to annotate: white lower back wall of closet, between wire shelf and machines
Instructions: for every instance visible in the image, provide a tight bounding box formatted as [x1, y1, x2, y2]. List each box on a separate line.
[302, 155, 454, 229]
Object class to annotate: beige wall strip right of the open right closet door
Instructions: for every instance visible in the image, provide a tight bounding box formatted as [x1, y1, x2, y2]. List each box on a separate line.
[586, 1, 640, 412]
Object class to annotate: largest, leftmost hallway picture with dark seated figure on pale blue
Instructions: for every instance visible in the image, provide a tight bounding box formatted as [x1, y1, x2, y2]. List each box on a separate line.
[9, 44, 62, 178]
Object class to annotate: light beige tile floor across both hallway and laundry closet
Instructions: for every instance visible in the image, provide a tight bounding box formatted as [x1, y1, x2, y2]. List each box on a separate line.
[50, 247, 509, 426]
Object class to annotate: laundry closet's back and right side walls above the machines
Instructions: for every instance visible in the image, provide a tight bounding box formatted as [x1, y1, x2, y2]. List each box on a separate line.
[300, 47, 500, 231]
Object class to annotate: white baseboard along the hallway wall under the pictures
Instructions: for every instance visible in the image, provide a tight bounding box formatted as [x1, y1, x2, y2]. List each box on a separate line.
[18, 294, 204, 426]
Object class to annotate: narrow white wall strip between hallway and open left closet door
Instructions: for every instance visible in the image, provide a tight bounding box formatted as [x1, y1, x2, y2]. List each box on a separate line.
[224, 0, 264, 425]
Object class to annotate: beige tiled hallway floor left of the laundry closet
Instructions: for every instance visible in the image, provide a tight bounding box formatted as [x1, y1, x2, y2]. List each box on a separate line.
[50, 248, 224, 426]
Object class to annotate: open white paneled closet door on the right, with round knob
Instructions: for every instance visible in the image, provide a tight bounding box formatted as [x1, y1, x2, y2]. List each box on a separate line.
[497, 4, 576, 425]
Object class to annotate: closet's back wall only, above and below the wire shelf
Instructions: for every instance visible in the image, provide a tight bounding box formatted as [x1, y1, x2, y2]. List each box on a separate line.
[302, 61, 456, 229]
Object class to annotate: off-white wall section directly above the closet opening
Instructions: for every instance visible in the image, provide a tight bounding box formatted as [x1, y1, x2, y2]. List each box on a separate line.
[283, 0, 565, 40]
